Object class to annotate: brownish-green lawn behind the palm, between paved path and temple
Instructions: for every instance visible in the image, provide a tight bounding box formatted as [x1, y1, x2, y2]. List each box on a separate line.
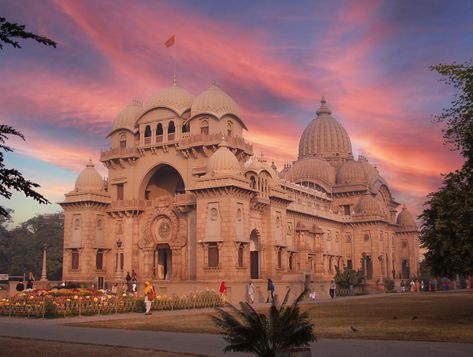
[76, 293, 473, 343]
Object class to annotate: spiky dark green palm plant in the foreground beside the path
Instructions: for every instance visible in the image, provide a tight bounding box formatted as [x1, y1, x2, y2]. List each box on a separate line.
[211, 290, 316, 357]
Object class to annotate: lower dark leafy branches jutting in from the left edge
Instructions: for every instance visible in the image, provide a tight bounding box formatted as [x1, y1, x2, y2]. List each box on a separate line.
[0, 124, 49, 217]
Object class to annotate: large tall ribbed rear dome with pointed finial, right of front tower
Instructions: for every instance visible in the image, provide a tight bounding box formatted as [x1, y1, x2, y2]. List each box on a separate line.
[299, 98, 352, 158]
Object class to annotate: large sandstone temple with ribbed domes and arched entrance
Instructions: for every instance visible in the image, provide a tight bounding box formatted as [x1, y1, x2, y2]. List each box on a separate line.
[61, 83, 419, 301]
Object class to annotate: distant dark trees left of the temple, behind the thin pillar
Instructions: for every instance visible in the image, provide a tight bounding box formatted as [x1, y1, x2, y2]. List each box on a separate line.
[0, 213, 64, 280]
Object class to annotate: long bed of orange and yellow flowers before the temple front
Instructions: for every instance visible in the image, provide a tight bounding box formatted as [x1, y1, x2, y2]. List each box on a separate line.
[0, 289, 224, 318]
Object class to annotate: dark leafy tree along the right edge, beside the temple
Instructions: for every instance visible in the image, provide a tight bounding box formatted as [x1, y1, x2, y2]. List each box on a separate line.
[420, 63, 473, 276]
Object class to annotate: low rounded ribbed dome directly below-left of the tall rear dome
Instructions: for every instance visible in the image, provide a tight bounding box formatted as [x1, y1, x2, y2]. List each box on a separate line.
[284, 157, 335, 191]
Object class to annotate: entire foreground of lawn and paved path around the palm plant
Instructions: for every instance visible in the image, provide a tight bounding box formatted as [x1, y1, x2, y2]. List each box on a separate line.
[0, 291, 473, 357]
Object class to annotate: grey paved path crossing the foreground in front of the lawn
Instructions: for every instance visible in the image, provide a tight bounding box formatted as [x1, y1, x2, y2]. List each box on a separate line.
[0, 295, 473, 357]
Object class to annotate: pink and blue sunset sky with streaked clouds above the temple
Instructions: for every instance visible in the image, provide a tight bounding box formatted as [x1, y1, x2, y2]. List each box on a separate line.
[0, 0, 473, 223]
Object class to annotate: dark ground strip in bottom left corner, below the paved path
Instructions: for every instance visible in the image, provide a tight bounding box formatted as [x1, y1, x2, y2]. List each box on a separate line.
[0, 337, 206, 357]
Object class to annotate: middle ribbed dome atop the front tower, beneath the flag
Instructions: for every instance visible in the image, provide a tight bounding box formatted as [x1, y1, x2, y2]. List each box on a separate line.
[144, 84, 194, 115]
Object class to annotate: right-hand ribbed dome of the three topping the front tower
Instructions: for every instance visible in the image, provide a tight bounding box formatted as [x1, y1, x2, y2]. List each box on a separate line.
[191, 84, 240, 119]
